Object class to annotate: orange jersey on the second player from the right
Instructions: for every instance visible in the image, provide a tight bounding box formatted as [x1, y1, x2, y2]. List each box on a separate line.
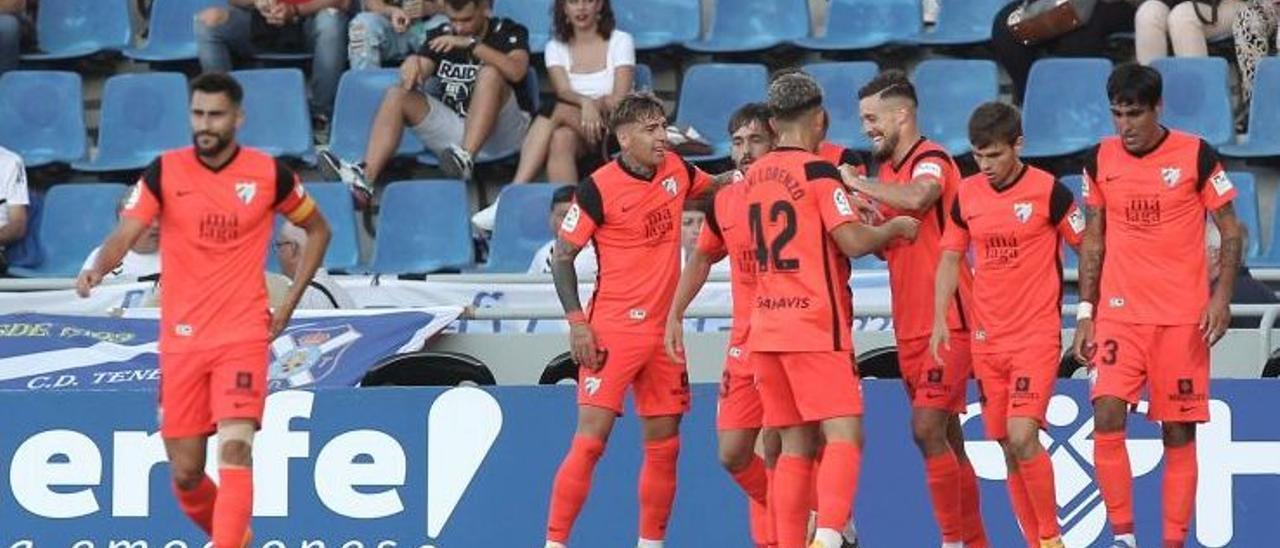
[942, 165, 1084, 353]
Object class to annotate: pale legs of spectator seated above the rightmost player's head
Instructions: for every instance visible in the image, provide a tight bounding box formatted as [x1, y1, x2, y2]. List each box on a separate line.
[1133, 0, 1243, 65]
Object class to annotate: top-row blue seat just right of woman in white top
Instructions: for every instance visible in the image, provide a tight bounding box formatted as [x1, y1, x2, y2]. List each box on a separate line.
[611, 0, 703, 51]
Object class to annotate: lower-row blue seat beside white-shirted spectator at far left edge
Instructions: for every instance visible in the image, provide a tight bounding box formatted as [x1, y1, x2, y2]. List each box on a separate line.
[9, 183, 128, 278]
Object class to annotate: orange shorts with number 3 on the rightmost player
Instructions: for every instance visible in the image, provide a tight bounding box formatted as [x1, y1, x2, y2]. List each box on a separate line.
[1089, 320, 1208, 423]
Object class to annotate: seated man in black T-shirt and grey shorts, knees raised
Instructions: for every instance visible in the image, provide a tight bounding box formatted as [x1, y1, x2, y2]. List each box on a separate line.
[320, 0, 532, 204]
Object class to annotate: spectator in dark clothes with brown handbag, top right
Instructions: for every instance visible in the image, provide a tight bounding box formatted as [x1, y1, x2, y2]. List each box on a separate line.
[991, 0, 1137, 104]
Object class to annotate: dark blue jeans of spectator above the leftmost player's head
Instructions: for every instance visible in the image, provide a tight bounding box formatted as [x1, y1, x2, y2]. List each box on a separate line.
[195, 8, 347, 117]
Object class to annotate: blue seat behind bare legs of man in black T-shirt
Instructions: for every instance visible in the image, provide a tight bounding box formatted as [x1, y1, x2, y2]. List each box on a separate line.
[329, 68, 422, 161]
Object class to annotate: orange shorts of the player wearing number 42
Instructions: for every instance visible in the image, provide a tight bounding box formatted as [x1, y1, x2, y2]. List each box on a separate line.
[750, 351, 863, 428]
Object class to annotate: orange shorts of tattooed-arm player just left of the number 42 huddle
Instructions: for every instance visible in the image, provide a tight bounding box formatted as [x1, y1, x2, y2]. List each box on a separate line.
[577, 332, 689, 416]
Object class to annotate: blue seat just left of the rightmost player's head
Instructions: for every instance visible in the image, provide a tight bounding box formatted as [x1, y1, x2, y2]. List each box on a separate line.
[1023, 59, 1114, 157]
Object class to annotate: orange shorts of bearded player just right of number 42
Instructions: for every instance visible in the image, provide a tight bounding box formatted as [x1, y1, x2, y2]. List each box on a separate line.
[897, 332, 973, 414]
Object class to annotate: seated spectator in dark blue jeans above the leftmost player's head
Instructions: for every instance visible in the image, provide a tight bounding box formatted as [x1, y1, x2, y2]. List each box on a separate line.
[196, 0, 352, 126]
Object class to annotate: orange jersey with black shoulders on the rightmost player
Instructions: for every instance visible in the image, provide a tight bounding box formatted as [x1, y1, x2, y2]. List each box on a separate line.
[1083, 129, 1236, 325]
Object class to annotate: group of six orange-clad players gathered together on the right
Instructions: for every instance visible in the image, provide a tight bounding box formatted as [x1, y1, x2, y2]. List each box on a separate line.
[547, 65, 1243, 548]
